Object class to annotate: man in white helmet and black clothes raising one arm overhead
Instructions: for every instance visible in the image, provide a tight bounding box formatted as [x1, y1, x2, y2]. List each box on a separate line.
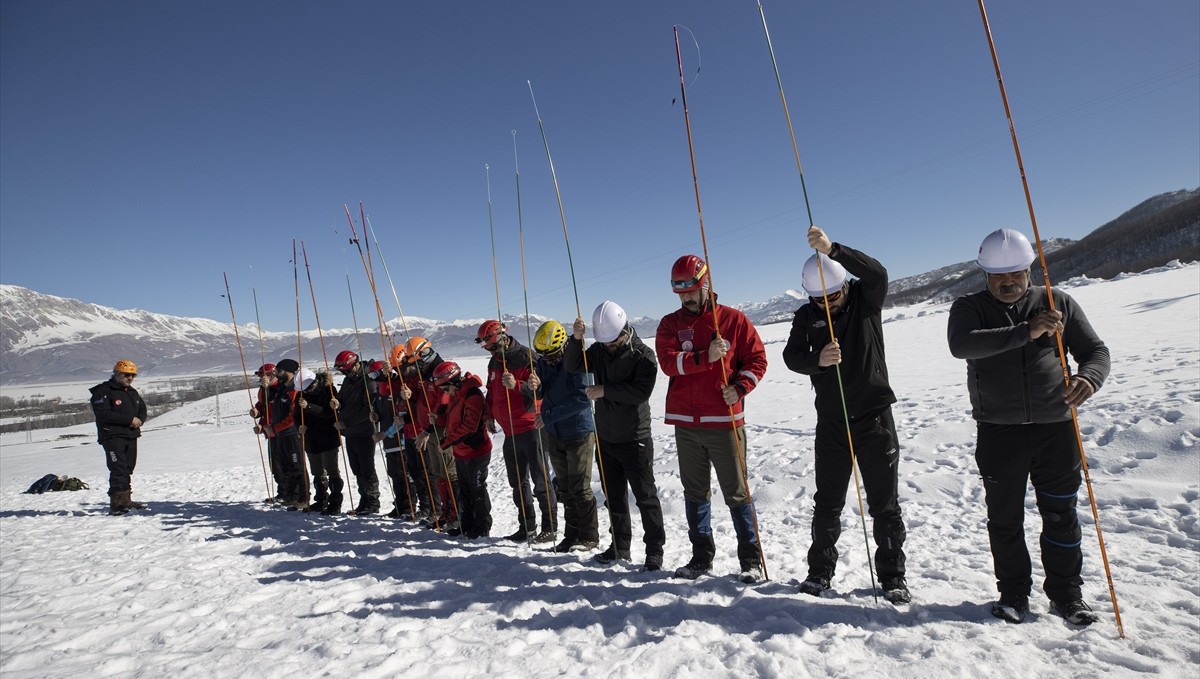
[784, 227, 912, 603]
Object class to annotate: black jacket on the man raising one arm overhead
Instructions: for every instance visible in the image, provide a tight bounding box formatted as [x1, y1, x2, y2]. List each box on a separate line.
[784, 244, 896, 422]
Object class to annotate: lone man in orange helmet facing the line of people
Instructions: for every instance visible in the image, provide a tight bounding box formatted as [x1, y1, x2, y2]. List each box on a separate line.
[90, 360, 146, 516]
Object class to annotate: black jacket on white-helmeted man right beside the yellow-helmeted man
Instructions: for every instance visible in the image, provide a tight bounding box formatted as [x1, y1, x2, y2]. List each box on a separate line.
[563, 328, 659, 443]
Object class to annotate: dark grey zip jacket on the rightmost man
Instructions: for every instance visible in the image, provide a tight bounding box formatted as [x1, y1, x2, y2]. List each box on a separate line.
[946, 286, 1110, 425]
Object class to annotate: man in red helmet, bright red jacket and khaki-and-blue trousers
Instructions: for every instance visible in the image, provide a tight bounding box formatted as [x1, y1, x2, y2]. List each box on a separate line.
[654, 254, 767, 582]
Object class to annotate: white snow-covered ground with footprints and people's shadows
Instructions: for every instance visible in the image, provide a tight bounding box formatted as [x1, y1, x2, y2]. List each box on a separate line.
[0, 264, 1200, 679]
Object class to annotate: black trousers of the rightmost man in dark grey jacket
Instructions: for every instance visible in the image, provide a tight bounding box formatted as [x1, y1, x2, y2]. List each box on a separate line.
[976, 420, 1084, 601]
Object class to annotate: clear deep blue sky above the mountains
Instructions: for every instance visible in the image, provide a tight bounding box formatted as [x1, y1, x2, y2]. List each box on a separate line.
[0, 0, 1200, 330]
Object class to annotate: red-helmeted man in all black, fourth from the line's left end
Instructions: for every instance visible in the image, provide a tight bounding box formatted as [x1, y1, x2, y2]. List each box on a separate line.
[329, 351, 379, 515]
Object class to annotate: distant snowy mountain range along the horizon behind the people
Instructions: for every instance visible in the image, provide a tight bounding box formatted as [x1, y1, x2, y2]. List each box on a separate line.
[0, 188, 1200, 384]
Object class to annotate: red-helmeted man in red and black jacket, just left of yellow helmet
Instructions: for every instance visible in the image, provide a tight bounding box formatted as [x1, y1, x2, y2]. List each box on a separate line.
[475, 320, 558, 542]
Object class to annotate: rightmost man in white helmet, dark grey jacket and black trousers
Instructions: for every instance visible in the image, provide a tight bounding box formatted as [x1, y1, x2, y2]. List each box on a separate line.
[947, 229, 1109, 625]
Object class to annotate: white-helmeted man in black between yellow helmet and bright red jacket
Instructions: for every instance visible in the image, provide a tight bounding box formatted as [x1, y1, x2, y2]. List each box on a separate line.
[563, 301, 667, 571]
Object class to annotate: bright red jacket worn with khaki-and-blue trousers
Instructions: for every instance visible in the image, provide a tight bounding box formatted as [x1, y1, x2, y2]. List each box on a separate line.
[654, 298, 767, 429]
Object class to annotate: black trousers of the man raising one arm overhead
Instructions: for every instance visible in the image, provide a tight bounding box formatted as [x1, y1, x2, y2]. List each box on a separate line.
[809, 408, 906, 579]
